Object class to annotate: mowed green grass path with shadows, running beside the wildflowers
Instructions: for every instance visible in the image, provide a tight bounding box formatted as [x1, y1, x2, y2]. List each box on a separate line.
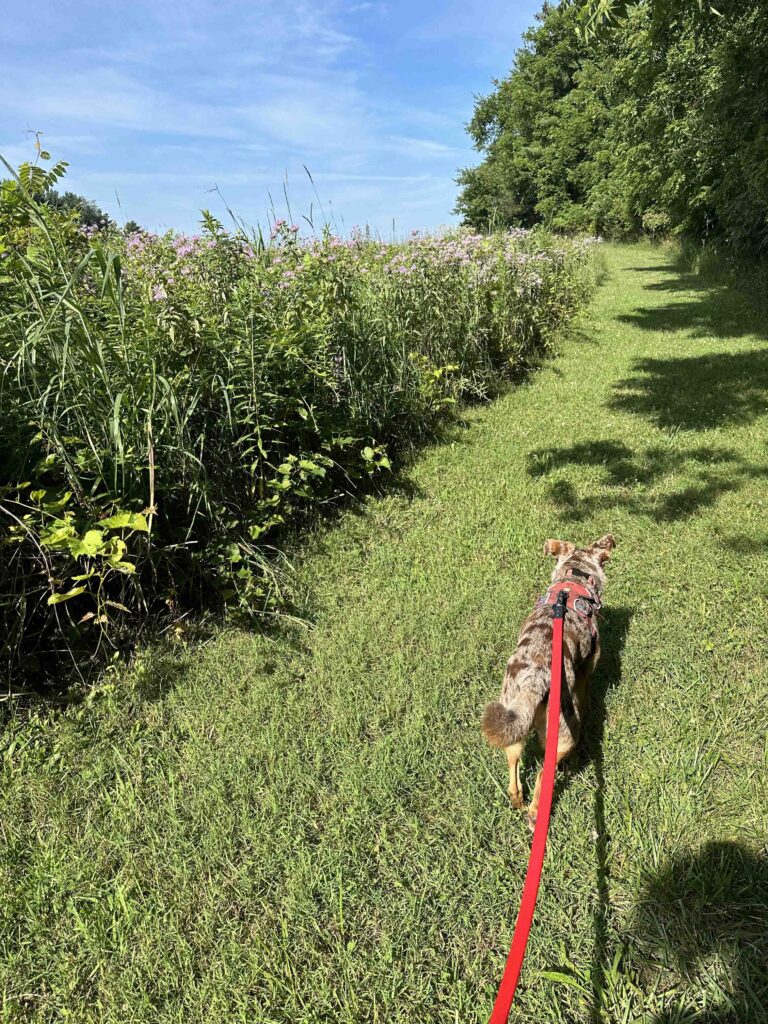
[0, 247, 768, 1024]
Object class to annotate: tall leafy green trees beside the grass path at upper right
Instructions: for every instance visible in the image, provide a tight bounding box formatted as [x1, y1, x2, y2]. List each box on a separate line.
[458, 0, 768, 254]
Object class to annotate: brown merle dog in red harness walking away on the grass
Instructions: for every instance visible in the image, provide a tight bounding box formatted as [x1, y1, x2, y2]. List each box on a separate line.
[482, 534, 615, 829]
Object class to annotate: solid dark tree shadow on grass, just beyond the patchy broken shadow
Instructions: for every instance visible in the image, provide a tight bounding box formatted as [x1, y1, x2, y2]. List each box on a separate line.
[608, 350, 768, 430]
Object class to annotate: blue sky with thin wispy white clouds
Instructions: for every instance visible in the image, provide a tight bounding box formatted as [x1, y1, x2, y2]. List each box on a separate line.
[0, 0, 541, 234]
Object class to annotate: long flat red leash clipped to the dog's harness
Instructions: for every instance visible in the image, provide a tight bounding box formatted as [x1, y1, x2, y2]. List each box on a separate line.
[488, 591, 567, 1024]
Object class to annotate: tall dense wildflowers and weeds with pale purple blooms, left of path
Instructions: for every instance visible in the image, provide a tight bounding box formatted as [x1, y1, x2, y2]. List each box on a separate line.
[0, 159, 602, 684]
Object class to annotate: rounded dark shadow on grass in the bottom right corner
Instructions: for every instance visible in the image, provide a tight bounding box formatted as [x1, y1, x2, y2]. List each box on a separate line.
[633, 841, 768, 1024]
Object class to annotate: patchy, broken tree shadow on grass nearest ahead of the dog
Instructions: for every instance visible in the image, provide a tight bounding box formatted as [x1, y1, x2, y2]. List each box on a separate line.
[527, 439, 768, 522]
